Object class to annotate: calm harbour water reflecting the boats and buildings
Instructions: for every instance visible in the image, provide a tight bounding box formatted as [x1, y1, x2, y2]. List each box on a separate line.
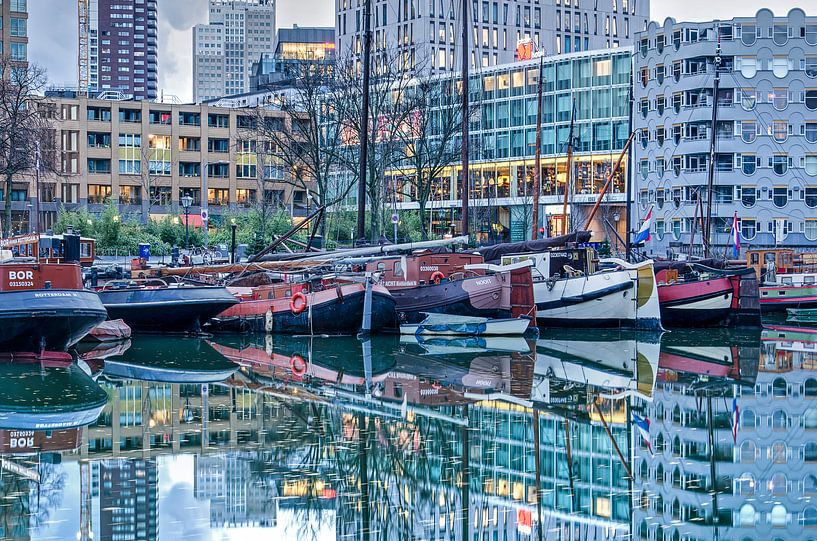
[0, 327, 817, 541]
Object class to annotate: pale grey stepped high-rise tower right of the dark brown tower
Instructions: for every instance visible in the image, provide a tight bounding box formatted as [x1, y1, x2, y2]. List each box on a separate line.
[193, 0, 275, 103]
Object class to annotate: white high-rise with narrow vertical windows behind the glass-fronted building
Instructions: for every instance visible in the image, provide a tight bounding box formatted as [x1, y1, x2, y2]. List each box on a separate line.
[335, 0, 650, 73]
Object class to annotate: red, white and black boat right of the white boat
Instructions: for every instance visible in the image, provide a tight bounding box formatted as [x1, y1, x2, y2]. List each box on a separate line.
[655, 261, 760, 327]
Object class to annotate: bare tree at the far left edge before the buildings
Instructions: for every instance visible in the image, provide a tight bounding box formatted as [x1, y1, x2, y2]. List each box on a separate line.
[0, 55, 55, 237]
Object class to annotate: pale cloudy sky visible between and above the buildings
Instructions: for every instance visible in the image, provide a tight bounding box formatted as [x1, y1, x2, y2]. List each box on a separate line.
[28, 0, 804, 101]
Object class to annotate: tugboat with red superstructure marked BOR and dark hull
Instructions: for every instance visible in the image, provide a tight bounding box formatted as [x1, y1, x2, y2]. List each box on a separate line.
[0, 243, 107, 352]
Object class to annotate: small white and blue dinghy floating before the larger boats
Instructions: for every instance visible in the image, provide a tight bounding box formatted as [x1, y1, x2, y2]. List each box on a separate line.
[400, 314, 530, 336]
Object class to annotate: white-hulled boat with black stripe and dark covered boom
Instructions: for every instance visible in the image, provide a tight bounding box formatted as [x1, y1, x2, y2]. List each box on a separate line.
[494, 248, 662, 330]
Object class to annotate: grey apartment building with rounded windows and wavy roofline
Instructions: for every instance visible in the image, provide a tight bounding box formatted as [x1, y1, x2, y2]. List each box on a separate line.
[633, 9, 817, 255]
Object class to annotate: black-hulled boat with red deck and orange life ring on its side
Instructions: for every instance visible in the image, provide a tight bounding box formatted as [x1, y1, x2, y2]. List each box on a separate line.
[208, 279, 394, 334]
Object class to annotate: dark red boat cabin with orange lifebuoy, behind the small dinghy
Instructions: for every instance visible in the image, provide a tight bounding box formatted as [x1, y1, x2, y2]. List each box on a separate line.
[366, 252, 485, 289]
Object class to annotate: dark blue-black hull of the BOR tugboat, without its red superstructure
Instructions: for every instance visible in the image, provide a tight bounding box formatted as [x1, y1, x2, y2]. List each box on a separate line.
[0, 289, 107, 352]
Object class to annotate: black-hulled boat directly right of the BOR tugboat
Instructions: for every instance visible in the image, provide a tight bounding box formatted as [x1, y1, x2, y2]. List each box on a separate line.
[99, 283, 238, 332]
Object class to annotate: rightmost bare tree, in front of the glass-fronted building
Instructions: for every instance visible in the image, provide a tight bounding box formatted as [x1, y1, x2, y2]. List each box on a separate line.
[398, 78, 462, 240]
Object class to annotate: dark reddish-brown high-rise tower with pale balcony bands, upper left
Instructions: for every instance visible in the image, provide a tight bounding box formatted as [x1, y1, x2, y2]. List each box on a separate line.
[88, 0, 159, 100]
